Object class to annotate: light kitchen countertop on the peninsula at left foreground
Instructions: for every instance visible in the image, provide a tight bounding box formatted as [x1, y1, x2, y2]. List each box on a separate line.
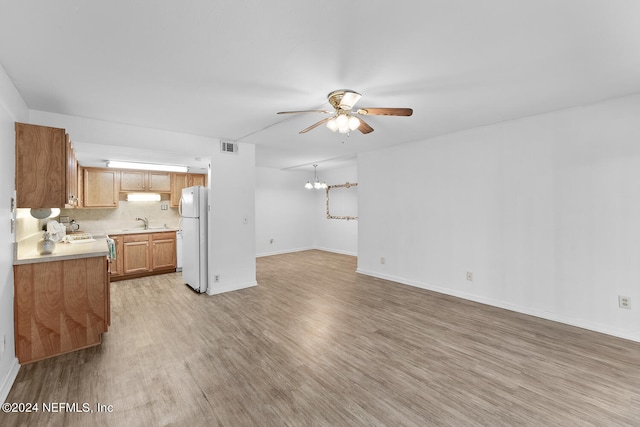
[13, 233, 109, 265]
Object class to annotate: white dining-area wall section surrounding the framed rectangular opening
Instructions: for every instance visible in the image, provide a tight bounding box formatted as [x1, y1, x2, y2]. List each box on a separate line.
[314, 164, 358, 256]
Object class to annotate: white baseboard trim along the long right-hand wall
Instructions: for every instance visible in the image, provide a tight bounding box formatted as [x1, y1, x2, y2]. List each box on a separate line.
[356, 268, 640, 342]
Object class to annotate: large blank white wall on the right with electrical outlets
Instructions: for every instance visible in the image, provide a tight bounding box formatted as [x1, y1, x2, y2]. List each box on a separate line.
[358, 96, 640, 341]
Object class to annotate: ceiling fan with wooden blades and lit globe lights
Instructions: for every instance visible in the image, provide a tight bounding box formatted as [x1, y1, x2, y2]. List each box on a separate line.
[278, 89, 413, 134]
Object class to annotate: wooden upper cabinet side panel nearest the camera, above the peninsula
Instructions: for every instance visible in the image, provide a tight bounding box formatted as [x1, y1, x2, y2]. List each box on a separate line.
[16, 123, 68, 208]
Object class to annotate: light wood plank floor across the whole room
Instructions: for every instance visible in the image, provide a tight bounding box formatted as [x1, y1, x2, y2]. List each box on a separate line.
[0, 251, 640, 426]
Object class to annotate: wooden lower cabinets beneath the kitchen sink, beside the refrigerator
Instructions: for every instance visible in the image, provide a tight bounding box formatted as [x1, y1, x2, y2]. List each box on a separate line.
[109, 231, 177, 280]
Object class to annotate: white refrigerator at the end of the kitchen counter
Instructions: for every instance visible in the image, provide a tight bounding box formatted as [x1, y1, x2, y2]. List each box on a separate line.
[180, 185, 209, 292]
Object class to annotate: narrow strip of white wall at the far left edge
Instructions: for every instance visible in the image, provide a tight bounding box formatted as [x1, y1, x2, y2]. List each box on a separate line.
[0, 61, 29, 402]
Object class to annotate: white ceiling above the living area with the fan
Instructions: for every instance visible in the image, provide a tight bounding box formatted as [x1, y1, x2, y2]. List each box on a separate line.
[0, 0, 640, 169]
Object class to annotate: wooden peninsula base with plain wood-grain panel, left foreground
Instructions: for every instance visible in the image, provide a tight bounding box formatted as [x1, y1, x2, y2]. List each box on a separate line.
[14, 256, 111, 364]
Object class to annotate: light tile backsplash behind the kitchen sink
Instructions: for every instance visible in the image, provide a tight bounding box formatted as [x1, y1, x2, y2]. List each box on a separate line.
[56, 200, 181, 234]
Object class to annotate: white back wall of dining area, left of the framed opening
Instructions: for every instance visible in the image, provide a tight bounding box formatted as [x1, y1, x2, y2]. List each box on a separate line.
[255, 167, 316, 256]
